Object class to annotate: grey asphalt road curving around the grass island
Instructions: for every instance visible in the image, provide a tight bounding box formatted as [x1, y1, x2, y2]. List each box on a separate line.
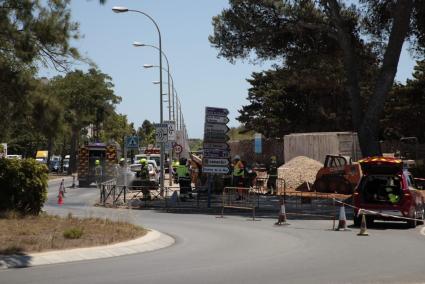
[0, 179, 425, 284]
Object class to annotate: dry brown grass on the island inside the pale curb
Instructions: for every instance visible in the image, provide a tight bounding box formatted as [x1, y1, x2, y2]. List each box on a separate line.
[0, 213, 148, 254]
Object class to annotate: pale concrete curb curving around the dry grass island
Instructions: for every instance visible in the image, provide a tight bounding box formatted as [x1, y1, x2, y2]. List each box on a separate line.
[0, 230, 175, 269]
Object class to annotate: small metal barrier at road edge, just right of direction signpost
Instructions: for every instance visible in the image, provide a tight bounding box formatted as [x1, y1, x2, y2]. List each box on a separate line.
[221, 187, 258, 221]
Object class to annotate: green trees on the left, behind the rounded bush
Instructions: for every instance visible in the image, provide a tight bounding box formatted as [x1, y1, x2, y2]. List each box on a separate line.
[0, 0, 155, 170]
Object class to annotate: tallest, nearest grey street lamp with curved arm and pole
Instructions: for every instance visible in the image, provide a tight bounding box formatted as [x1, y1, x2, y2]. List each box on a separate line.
[112, 6, 165, 192]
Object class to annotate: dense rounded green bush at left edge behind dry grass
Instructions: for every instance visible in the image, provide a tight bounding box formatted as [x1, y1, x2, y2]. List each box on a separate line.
[0, 158, 48, 215]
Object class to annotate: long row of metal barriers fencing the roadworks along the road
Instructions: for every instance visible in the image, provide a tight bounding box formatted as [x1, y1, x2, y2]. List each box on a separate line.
[99, 180, 345, 222]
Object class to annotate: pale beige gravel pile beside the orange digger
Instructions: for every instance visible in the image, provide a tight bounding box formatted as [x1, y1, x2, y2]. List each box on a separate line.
[277, 156, 323, 189]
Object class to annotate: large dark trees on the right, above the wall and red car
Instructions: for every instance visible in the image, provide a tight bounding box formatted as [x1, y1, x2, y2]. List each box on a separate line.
[209, 0, 425, 156]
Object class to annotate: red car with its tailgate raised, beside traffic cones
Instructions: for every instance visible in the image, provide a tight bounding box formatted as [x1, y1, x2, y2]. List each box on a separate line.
[353, 157, 424, 228]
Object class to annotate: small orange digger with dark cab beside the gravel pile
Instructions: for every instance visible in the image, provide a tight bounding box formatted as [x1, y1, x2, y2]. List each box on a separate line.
[313, 155, 362, 194]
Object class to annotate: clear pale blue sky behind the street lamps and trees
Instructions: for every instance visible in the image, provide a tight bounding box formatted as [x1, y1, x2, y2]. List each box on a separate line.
[40, 0, 414, 138]
